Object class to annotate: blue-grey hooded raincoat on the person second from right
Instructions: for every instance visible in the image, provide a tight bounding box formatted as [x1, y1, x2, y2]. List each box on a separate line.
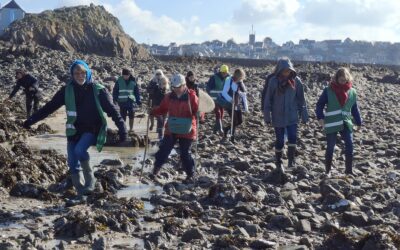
[264, 59, 308, 128]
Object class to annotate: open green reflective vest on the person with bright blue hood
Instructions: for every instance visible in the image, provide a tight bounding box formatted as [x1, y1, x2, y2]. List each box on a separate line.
[64, 82, 107, 152]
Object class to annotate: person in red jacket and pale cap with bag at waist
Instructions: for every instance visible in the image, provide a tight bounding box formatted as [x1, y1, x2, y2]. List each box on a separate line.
[150, 74, 199, 183]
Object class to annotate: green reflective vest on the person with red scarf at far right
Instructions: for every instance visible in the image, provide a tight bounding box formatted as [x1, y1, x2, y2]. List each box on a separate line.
[325, 87, 356, 134]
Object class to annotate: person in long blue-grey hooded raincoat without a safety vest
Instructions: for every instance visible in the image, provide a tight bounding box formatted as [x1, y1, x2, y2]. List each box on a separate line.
[264, 57, 308, 172]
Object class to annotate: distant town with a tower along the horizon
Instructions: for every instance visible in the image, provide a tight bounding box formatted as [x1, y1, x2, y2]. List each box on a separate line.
[143, 28, 400, 65]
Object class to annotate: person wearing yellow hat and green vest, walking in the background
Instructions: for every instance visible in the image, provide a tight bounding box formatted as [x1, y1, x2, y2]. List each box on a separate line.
[206, 64, 229, 135]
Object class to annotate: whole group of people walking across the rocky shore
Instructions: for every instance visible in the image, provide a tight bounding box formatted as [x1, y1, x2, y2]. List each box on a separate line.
[9, 58, 361, 205]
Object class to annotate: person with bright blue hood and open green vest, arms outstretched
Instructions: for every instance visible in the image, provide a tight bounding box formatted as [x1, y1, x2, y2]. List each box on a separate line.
[23, 60, 127, 205]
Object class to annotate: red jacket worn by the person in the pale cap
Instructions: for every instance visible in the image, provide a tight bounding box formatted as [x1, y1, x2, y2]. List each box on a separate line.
[152, 89, 199, 140]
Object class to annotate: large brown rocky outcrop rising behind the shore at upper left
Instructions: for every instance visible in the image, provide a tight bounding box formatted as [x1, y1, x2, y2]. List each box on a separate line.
[2, 4, 150, 59]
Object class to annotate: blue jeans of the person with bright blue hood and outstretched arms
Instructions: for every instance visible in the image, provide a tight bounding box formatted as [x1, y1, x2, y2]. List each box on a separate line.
[67, 133, 96, 174]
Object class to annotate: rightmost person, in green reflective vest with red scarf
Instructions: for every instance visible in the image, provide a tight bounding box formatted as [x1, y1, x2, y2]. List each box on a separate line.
[315, 68, 362, 175]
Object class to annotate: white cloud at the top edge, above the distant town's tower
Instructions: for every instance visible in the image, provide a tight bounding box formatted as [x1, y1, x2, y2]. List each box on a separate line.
[233, 0, 300, 25]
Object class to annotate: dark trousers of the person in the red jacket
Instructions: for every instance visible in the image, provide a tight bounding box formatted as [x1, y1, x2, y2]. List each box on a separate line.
[154, 135, 194, 176]
